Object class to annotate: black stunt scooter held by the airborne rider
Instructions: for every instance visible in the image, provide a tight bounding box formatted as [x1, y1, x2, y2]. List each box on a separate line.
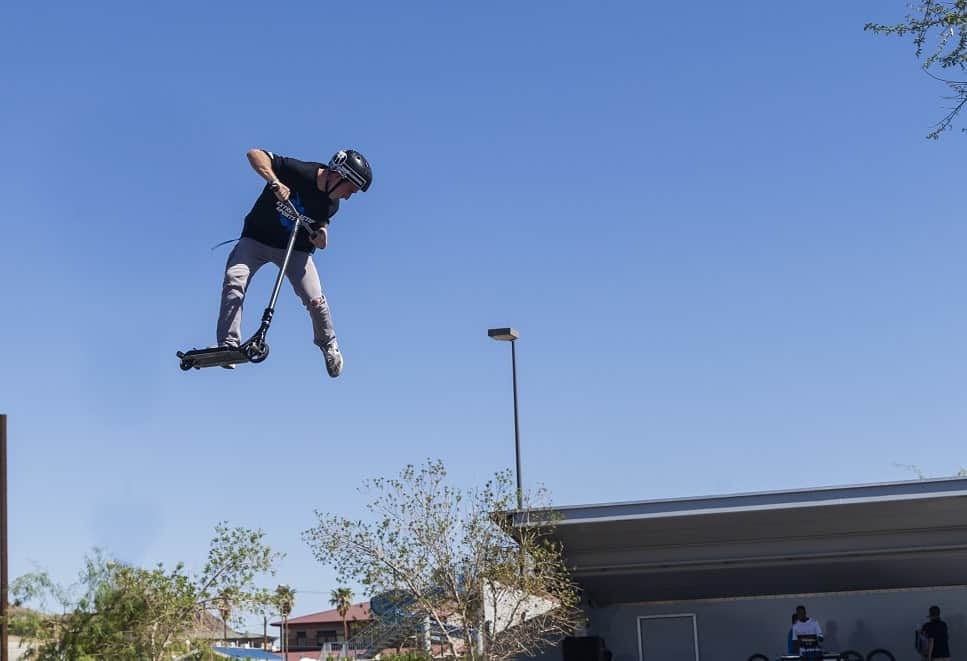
[175, 200, 316, 372]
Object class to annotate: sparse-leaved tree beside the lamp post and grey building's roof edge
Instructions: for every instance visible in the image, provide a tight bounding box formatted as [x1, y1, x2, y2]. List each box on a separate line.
[303, 461, 578, 661]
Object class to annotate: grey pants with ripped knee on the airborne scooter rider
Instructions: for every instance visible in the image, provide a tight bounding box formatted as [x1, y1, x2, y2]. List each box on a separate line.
[216, 237, 336, 349]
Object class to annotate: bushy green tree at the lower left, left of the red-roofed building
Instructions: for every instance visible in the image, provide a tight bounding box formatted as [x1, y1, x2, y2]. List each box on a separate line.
[11, 524, 279, 661]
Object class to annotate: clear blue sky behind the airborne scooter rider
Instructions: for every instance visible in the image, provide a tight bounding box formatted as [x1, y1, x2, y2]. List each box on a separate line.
[0, 0, 967, 628]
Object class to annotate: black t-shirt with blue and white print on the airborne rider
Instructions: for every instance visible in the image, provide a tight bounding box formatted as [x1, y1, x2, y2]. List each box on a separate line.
[242, 151, 339, 253]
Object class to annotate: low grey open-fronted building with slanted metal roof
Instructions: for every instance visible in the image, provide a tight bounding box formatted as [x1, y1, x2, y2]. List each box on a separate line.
[512, 477, 967, 661]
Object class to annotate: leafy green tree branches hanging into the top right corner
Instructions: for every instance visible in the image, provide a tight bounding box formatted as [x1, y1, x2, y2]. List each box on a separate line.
[864, 0, 967, 140]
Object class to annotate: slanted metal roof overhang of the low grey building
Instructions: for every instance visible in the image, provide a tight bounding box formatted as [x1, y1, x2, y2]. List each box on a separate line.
[511, 478, 967, 604]
